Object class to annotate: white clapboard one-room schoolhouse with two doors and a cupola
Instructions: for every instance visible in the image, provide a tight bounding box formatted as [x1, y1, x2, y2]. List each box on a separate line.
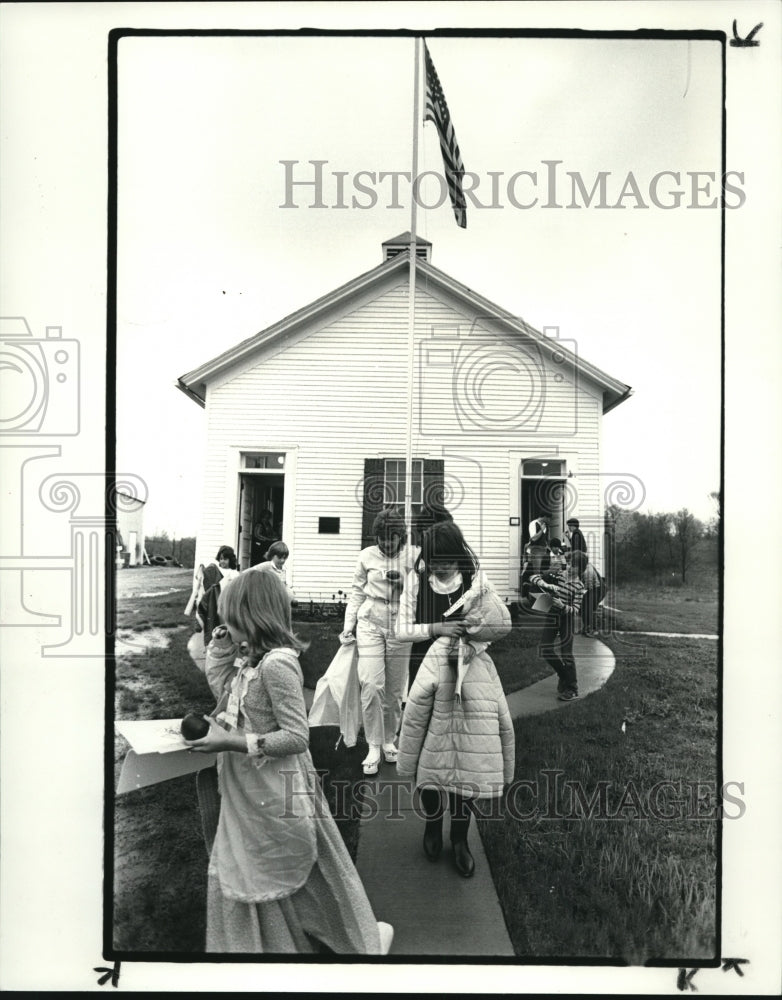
[178, 233, 631, 601]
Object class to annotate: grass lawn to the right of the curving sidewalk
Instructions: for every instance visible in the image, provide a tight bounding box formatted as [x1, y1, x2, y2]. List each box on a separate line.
[479, 637, 717, 964]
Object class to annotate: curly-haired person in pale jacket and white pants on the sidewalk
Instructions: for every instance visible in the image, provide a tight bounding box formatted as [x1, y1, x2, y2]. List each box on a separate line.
[339, 510, 418, 774]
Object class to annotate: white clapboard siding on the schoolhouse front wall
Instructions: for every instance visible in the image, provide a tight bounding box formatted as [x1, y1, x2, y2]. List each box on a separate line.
[198, 280, 602, 599]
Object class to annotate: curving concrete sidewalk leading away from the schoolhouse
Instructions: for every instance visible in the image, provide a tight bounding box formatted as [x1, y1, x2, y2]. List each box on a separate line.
[356, 636, 614, 957]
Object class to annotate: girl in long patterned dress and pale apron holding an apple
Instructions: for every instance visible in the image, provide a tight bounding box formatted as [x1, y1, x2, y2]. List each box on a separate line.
[189, 573, 393, 955]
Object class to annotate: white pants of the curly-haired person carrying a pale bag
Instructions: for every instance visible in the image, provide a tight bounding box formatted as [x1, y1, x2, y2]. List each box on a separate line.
[356, 598, 410, 746]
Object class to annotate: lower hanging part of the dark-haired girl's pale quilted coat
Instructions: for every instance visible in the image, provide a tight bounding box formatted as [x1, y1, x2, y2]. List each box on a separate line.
[397, 638, 515, 799]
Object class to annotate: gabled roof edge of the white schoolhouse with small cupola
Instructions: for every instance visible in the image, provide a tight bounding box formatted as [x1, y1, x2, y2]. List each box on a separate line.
[177, 244, 632, 413]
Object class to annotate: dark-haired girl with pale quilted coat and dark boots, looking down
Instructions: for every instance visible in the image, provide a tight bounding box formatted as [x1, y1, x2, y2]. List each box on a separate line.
[396, 521, 515, 878]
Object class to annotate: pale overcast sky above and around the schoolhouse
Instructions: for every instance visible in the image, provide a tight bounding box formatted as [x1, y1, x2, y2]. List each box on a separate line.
[117, 31, 724, 536]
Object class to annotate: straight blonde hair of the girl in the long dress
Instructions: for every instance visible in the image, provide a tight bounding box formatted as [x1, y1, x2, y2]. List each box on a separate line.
[217, 572, 309, 656]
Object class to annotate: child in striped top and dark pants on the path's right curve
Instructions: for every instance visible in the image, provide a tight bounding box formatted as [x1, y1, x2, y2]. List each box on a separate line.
[530, 550, 587, 701]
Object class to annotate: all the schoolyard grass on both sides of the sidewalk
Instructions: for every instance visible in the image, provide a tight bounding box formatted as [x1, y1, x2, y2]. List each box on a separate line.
[114, 568, 717, 964]
